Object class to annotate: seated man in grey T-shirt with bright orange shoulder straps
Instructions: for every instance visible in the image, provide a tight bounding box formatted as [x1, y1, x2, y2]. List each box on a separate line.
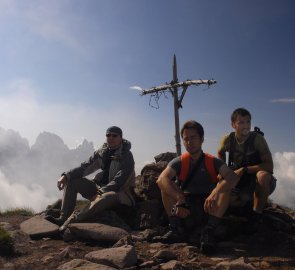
[154, 121, 238, 254]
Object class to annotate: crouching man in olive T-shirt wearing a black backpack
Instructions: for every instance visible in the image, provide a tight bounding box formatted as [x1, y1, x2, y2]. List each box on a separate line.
[218, 108, 276, 225]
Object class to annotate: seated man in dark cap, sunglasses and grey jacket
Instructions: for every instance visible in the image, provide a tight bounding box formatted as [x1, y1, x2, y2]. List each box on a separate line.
[45, 126, 135, 231]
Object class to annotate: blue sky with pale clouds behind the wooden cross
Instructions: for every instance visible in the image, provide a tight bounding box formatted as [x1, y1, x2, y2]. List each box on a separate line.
[0, 0, 295, 210]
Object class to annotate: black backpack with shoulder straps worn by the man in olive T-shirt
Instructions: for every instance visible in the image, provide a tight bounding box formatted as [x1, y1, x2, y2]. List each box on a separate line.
[228, 127, 264, 170]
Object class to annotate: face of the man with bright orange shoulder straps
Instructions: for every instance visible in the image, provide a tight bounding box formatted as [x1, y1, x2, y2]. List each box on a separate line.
[182, 128, 204, 154]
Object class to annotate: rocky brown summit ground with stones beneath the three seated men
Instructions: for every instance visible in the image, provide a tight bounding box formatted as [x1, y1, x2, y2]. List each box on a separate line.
[0, 153, 295, 270]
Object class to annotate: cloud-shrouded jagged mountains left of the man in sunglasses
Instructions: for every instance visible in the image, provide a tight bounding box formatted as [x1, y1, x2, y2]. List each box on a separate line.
[0, 128, 94, 212]
